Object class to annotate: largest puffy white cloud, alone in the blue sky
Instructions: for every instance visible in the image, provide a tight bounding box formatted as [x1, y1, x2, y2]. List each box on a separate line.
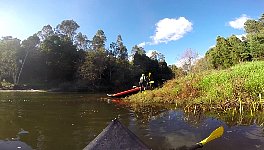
[150, 17, 192, 44]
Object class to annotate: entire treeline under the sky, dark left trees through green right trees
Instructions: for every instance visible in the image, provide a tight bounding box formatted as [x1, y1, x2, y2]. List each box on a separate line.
[0, 14, 264, 90]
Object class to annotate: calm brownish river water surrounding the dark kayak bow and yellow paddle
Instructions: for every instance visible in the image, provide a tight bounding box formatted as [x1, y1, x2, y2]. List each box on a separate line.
[0, 92, 264, 150]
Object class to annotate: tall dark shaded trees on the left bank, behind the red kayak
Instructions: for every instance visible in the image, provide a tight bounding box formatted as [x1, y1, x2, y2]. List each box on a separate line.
[0, 20, 173, 90]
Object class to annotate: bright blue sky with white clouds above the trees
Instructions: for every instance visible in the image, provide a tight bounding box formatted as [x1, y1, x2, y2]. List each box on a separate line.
[0, 0, 264, 65]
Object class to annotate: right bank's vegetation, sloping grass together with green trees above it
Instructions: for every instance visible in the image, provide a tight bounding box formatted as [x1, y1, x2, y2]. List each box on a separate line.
[126, 14, 264, 114]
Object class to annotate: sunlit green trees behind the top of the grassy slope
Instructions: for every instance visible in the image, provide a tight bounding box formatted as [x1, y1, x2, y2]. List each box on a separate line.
[204, 14, 264, 69]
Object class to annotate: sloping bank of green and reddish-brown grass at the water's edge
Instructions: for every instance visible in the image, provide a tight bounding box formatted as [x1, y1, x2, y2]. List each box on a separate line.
[127, 61, 264, 113]
